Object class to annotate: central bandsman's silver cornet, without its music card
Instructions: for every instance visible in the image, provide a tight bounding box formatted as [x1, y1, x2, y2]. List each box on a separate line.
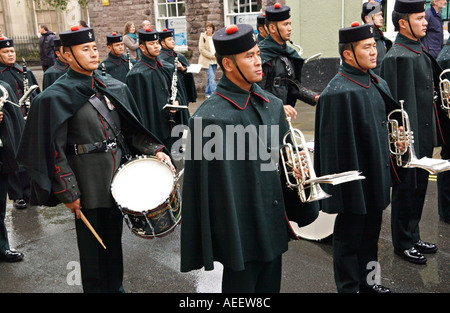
[280, 117, 330, 202]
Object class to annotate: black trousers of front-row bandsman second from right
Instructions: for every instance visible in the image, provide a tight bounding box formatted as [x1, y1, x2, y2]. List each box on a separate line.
[333, 210, 383, 292]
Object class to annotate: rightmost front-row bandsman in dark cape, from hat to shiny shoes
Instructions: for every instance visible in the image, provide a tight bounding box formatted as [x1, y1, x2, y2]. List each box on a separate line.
[381, 0, 450, 264]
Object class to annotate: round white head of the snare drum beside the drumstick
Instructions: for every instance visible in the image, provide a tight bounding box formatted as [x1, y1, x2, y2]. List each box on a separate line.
[111, 158, 174, 212]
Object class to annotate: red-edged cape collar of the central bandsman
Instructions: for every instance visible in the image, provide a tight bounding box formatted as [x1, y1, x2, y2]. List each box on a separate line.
[216, 75, 270, 110]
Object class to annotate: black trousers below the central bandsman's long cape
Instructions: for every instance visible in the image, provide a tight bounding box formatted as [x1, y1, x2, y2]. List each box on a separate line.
[222, 255, 281, 293]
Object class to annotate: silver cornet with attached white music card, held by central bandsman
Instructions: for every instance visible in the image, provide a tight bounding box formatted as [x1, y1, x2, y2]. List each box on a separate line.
[280, 117, 365, 202]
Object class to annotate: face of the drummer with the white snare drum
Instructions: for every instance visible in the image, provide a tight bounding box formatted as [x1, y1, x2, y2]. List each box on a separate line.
[64, 42, 98, 75]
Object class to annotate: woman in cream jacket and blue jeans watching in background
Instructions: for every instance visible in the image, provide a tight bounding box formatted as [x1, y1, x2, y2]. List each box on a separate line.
[198, 22, 217, 98]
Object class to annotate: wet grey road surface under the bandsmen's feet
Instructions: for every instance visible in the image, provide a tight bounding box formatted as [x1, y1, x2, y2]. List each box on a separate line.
[0, 68, 450, 301]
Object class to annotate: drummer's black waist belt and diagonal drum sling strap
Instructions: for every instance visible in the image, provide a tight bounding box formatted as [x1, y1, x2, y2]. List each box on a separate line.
[75, 94, 130, 157]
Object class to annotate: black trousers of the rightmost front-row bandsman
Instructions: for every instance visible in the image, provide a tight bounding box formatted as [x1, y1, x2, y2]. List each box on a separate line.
[391, 169, 428, 251]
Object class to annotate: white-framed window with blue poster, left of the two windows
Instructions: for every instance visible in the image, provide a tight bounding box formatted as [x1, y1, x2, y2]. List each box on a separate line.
[155, 0, 187, 51]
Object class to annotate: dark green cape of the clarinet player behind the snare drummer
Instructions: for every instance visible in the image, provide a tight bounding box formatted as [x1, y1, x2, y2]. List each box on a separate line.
[126, 55, 189, 151]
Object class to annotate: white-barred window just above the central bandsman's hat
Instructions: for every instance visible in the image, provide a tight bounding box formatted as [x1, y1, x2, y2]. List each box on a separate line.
[224, 0, 262, 29]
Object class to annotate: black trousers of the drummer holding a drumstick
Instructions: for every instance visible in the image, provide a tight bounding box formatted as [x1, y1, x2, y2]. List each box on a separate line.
[75, 207, 123, 293]
